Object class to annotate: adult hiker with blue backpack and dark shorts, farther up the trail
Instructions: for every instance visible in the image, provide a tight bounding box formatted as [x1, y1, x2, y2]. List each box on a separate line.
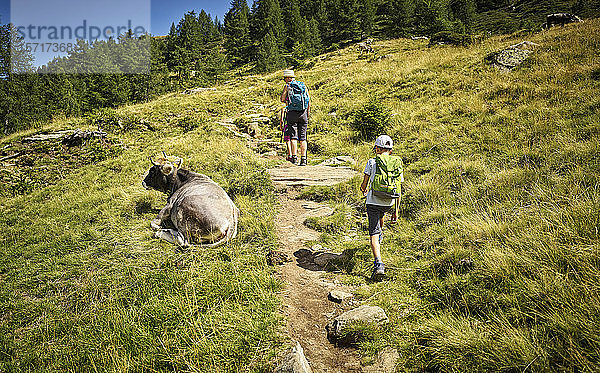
[281, 70, 310, 166]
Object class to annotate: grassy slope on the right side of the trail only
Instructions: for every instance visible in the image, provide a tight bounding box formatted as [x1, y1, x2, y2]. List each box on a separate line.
[303, 20, 600, 371]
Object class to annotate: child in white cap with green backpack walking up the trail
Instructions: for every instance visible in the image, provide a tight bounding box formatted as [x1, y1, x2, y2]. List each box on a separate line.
[360, 135, 404, 280]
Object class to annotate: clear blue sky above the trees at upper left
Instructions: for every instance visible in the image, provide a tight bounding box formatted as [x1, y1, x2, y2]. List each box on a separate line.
[0, 0, 230, 66]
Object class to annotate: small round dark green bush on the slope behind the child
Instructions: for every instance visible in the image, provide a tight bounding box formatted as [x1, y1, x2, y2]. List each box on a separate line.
[352, 97, 391, 140]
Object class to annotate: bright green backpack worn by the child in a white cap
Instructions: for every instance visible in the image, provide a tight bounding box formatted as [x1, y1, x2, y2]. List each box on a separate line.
[371, 154, 404, 198]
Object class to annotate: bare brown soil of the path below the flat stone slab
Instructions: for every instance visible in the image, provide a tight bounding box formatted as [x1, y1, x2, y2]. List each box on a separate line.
[276, 187, 362, 373]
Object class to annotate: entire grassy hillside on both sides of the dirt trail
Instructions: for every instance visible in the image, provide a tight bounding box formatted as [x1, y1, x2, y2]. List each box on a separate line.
[0, 20, 600, 372]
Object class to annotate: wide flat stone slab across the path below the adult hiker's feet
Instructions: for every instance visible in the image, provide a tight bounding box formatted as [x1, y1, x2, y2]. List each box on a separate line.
[268, 164, 358, 186]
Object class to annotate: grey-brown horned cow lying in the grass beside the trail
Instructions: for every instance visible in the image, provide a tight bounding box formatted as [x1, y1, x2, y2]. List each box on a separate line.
[142, 155, 240, 247]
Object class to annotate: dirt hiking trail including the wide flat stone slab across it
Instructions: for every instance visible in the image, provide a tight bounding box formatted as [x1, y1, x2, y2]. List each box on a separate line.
[269, 163, 393, 373]
